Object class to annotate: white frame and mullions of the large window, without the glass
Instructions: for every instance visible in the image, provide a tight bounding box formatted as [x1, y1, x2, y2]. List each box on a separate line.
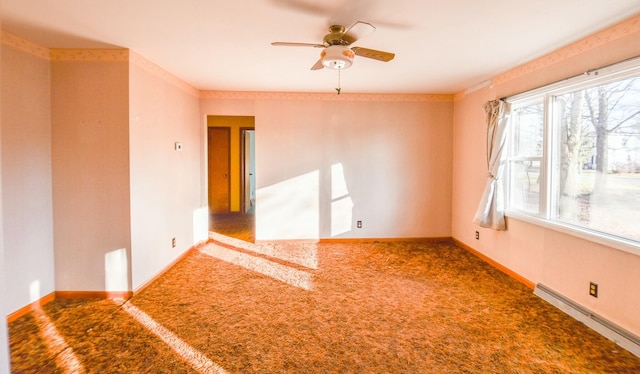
[505, 57, 640, 256]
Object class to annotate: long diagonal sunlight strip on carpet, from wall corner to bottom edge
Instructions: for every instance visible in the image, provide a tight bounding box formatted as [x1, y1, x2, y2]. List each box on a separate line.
[122, 303, 227, 374]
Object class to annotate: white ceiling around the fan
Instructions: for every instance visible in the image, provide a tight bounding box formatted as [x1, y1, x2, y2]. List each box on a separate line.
[2, 0, 640, 93]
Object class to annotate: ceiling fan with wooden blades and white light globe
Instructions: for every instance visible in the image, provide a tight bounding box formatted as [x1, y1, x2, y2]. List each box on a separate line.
[271, 21, 395, 70]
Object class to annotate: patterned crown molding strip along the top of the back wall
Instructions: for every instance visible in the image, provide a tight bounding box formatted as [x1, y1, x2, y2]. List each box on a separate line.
[200, 91, 453, 102]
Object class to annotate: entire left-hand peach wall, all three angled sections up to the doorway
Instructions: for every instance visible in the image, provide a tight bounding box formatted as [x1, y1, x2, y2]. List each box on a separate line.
[2, 31, 208, 322]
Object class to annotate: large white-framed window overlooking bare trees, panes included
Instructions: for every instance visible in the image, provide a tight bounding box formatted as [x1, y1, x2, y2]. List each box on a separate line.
[506, 60, 640, 253]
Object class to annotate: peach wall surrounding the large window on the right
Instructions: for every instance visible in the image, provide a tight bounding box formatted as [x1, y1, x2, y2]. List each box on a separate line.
[452, 15, 640, 335]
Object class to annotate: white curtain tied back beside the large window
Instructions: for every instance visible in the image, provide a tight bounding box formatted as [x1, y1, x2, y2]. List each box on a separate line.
[473, 100, 511, 230]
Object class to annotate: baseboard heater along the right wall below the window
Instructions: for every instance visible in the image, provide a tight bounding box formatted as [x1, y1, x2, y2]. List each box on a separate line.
[533, 283, 640, 357]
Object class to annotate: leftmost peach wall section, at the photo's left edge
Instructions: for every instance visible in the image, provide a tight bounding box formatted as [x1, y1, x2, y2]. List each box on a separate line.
[1, 41, 55, 313]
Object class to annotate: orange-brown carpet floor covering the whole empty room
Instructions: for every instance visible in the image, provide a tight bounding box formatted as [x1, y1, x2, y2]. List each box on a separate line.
[9, 212, 640, 373]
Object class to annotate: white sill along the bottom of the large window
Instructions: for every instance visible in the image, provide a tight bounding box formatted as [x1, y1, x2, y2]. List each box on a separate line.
[505, 211, 640, 256]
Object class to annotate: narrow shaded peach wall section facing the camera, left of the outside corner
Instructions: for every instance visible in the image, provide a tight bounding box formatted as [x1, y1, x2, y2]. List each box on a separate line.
[51, 50, 131, 291]
